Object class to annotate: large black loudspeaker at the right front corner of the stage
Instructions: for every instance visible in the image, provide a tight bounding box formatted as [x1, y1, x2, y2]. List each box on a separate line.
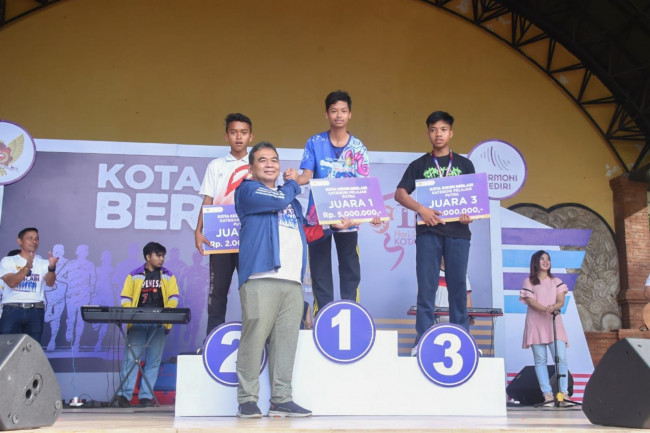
[582, 338, 650, 428]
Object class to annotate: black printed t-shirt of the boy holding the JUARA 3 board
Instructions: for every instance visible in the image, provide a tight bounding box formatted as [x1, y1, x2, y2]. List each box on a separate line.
[397, 152, 475, 239]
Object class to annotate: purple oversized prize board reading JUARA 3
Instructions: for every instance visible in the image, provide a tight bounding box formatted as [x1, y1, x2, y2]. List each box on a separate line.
[415, 173, 490, 224]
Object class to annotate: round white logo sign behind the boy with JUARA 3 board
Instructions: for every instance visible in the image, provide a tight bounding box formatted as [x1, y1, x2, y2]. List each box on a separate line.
[467, 140, 526, 200]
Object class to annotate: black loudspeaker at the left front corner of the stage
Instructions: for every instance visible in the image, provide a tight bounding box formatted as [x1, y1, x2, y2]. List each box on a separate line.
[0, 334, 63, 430]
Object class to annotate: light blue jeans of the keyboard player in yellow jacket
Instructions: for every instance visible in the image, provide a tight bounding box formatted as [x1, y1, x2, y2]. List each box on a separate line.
[119, 324, 166, 400]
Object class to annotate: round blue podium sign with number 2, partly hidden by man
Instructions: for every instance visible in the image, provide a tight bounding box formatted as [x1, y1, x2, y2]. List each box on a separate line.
[203, 322, 268, 386]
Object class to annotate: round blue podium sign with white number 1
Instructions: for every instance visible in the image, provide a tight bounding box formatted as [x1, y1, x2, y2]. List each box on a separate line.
[314, 301, 376, 364]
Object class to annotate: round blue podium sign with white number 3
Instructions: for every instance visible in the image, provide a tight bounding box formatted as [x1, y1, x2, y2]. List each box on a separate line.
[418, 323, 479, 387]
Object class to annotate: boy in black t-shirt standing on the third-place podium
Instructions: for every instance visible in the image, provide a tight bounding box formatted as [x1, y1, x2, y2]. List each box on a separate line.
[395, 111, 474, 350]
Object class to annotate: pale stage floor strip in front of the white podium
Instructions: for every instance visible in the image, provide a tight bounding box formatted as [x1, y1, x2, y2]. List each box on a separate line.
[16, 406, 639, 433]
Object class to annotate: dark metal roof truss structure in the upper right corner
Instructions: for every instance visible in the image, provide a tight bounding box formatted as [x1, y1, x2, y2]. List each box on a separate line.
[422, 0, 650, 180]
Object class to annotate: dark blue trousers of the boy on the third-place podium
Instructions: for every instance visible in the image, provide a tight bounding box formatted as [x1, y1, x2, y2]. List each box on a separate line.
[415, 232, 469, 343]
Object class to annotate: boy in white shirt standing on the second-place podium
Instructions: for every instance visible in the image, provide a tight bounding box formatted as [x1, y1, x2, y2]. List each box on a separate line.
[194, 113, 253, 335]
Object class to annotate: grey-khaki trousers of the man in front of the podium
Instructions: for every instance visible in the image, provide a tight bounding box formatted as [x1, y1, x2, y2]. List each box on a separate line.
[237, 278, 304, 404]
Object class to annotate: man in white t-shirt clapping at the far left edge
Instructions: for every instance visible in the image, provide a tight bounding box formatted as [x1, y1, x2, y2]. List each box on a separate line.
[0, 227, 59, 344]
